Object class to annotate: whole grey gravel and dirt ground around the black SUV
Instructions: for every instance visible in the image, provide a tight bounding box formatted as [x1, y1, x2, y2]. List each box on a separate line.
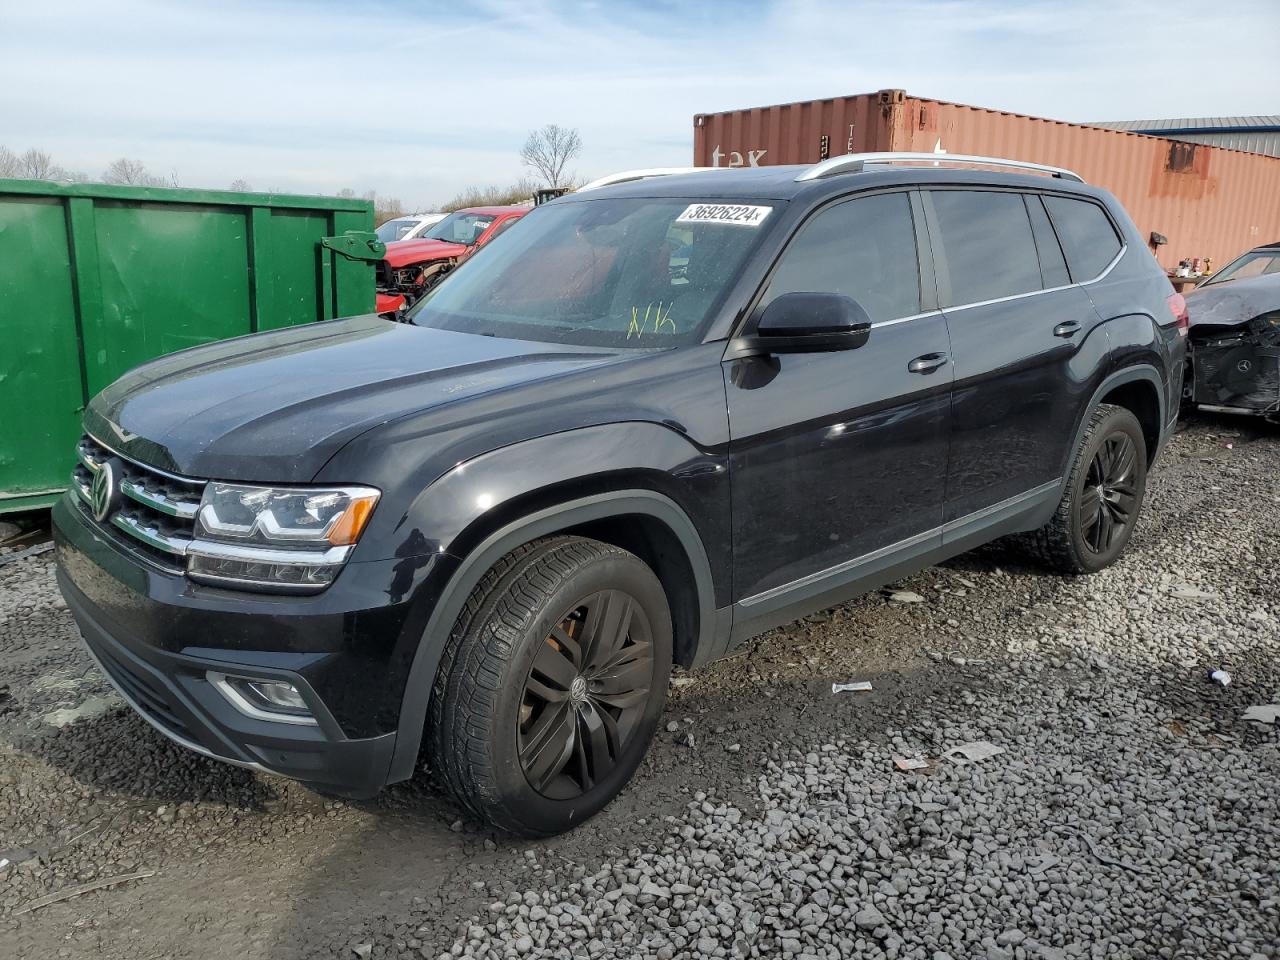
[0, 419, 1280, 960]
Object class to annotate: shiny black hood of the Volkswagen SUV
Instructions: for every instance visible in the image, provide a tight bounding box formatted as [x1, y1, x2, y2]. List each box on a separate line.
[84, 315, 625, 483]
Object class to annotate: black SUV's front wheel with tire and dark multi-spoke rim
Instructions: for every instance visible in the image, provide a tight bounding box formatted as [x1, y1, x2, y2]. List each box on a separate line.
[429, 536, 672, 836]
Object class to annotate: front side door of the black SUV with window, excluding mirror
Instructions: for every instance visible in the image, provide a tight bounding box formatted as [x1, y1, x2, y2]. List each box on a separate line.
[724, 192, 951, 635]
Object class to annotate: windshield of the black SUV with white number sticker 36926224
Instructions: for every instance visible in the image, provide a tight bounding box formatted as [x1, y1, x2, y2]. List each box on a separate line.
[411, 200, 772, 348]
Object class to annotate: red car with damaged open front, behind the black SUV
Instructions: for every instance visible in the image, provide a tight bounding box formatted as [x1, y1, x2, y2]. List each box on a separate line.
[376, 206, 532, 315]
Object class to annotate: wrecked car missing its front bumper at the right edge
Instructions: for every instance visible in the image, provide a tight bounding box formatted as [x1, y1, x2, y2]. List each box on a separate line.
[1183, 243, 1280, 421]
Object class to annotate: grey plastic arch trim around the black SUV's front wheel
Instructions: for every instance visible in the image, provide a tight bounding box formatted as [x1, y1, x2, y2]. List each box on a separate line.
[388, 488, 728, 782]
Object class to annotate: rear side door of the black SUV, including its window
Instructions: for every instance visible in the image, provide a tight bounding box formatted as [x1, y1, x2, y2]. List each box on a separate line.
[924, 188, 1107, 529]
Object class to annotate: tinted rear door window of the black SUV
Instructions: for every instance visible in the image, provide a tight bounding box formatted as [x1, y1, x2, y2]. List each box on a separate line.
[931, 189, 1042, 306]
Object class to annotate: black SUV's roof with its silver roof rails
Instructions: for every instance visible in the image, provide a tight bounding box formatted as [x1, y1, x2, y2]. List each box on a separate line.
[552, 164, 1106, 204]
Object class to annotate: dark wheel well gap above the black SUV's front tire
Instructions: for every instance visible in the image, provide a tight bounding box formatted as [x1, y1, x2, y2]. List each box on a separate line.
[561, 513, 701, 667]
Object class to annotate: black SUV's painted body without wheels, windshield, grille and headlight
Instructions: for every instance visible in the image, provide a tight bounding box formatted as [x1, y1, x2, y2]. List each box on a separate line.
[54, 168, 1184, 794]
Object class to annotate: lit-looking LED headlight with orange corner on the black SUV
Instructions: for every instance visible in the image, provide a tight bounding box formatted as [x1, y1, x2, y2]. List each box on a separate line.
[187, 481, 379, 593]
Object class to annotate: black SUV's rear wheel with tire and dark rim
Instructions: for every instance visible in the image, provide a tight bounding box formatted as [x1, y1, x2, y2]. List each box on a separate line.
[1021, 403, 1147, 575]
